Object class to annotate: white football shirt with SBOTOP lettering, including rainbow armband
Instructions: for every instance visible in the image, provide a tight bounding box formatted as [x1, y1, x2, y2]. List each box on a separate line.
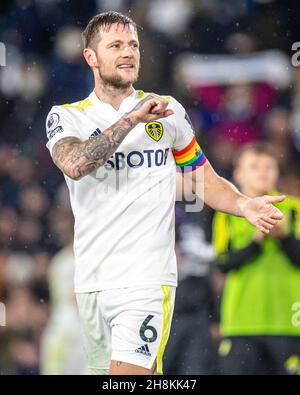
[46, 90, 206, 293]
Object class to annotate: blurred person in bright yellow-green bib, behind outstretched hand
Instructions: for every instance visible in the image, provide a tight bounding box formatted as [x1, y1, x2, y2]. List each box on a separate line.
[213, 144, 300, 374]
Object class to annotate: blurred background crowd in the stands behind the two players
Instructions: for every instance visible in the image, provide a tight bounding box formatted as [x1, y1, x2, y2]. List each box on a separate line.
[0, 0, 300, 375]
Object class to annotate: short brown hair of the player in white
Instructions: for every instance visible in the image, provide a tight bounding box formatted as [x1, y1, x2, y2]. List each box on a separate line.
[82, 11, 137, 48]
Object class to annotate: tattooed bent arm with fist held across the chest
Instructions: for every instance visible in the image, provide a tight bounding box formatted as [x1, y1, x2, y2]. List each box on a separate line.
[52, 94, 173, 180]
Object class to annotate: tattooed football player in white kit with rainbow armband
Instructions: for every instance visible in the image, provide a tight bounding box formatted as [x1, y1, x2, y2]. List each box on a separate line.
[46, 12, 283, 374]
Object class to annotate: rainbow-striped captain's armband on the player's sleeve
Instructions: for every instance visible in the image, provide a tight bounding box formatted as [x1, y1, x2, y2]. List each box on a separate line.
[172, 137, 206, 171]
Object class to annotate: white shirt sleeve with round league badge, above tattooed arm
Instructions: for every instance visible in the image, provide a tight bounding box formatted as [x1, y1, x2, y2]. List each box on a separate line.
[46, 106, 80, 155]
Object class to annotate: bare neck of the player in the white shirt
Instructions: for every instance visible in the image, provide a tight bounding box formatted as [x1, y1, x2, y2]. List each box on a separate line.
[95, 81, 134, 111]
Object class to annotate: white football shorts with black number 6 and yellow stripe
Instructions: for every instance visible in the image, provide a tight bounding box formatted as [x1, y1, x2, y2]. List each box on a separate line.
[76, 285, 176, 374]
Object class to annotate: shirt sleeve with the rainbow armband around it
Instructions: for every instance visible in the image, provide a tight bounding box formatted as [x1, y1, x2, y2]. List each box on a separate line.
[172, 98, 206, 171]
